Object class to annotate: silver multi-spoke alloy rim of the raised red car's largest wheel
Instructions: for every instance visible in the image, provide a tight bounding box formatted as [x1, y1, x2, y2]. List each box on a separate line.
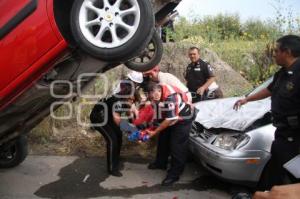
[79, 0, 140, 48]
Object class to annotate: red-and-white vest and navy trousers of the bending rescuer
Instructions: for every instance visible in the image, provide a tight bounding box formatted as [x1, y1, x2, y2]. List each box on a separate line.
[154, 85, 194, 179]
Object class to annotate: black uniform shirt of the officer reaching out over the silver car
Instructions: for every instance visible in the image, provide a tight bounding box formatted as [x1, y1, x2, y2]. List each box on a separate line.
[268, 58, 300, 119]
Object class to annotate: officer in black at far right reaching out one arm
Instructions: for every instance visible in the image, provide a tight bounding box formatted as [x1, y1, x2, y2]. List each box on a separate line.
[234, 35, 300, 190]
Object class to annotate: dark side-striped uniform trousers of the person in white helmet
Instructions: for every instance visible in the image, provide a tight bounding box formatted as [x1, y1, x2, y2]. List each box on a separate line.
[90, 99, 122, 172]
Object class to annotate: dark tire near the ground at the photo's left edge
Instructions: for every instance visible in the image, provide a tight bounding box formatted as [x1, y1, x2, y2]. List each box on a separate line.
[0, 135, 28, 168]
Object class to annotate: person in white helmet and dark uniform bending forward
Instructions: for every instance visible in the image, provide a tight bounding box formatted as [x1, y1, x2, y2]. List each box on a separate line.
[90, 71, 143, 177]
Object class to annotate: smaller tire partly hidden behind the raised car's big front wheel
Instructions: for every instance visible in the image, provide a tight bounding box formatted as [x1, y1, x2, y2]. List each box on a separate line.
[125, 31, 163, 72]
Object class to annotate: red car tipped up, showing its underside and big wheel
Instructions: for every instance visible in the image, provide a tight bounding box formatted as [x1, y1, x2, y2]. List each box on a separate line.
[0, 0, 179, 168]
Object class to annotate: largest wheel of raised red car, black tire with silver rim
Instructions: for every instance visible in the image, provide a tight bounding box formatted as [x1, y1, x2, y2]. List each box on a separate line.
[71, 0, 154, 62]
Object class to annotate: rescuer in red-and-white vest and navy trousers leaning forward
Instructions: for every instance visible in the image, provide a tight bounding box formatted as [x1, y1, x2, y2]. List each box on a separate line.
[148, 83, 193, 186]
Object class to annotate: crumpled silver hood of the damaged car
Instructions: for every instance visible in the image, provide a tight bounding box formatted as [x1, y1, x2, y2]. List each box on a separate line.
[194, 97, 271, 131]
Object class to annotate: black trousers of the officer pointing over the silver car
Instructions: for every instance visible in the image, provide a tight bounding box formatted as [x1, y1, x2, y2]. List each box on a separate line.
[258, 129, 300, 190]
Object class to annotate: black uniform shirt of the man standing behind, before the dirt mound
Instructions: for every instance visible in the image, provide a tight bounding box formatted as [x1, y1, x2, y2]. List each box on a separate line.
[185, 59, 215, 92]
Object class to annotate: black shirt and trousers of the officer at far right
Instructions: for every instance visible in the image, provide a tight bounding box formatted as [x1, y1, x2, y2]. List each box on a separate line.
[262, 59, 300, 189]
